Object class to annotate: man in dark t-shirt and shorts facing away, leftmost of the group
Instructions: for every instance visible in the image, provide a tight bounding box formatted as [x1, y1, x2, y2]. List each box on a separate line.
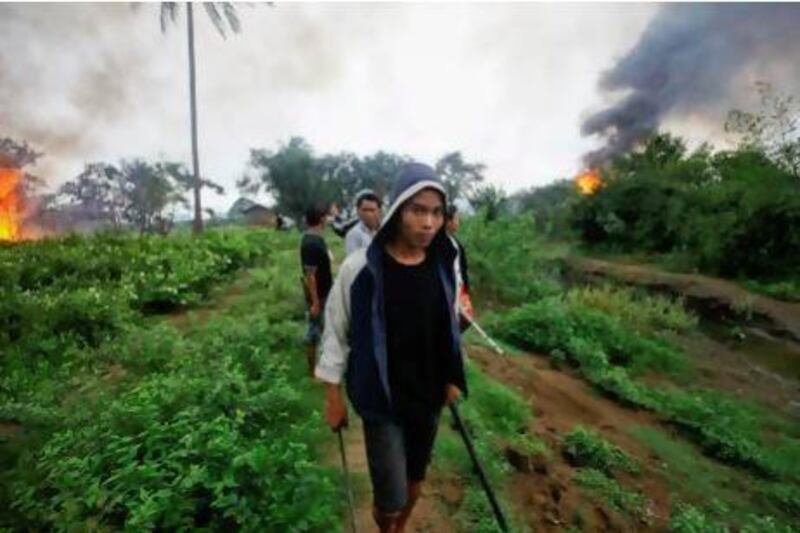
[300, 203, 333, 377]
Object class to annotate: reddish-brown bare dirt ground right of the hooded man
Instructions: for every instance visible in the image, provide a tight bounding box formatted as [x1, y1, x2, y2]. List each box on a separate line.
[467, 345, 671, 531]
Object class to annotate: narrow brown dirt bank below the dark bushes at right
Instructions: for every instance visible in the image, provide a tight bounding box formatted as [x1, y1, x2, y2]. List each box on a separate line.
[564, 257, 800, 342]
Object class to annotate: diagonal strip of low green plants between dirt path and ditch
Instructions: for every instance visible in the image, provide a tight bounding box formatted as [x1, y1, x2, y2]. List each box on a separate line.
[487, 298, 800, 481]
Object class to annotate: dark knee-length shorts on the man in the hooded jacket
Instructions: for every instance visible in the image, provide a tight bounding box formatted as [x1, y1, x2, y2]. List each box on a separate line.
[364, 412, 439, 513]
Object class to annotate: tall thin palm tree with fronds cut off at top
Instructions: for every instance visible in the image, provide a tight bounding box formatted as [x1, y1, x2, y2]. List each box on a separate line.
[161, 2, 241, 233]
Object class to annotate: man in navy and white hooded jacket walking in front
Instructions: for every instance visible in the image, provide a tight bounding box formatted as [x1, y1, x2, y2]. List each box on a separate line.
[316, 163, 467, 532]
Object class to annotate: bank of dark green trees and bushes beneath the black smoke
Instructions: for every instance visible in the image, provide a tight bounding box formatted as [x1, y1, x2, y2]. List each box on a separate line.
[514, 83, 800, 301]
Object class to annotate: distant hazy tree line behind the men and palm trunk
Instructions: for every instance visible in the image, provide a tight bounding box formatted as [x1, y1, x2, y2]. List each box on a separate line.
[0, 133, 505, 233]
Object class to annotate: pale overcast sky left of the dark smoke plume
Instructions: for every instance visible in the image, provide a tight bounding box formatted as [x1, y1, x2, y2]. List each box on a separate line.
[0, 3, 752, 214]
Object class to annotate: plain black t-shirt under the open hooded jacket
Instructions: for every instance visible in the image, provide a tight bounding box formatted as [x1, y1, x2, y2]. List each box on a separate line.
[383, 253, 450, 417]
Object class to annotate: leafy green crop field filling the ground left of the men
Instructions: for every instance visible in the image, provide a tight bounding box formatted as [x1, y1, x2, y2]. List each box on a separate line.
[0, 229, 341, 531]
